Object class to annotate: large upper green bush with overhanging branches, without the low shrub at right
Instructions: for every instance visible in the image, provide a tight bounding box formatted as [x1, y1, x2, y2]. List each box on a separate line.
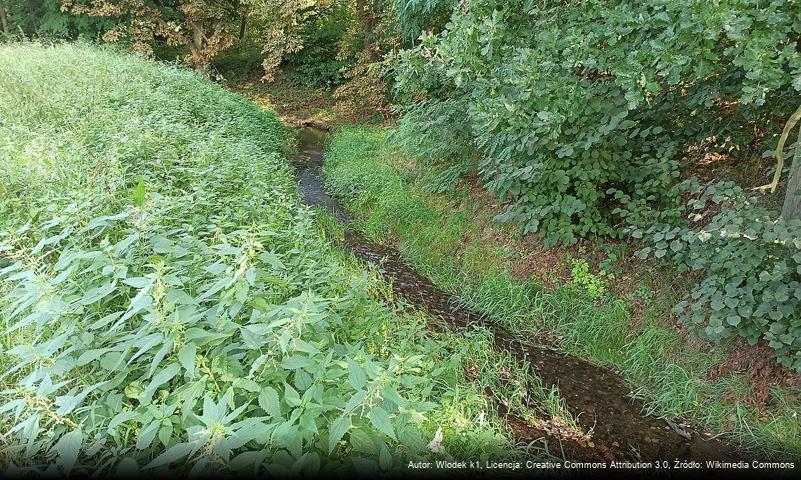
[396, 0, 801, 243]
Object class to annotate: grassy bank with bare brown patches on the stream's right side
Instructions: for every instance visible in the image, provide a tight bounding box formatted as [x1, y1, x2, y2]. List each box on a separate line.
[325, 126, 801, 458]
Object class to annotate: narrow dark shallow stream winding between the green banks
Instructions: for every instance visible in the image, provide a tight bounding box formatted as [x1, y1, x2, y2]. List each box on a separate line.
[295, 127, 747, 462]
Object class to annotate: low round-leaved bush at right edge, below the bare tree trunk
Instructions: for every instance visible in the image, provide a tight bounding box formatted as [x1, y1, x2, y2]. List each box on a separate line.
[631, 181, 801, 370]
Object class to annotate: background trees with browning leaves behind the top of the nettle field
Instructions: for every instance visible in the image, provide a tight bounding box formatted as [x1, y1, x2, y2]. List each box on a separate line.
[0, 0, 358, 78]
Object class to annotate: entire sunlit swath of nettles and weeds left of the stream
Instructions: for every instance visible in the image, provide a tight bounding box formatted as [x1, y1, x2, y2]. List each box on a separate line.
[0, 45, 544, 474]
